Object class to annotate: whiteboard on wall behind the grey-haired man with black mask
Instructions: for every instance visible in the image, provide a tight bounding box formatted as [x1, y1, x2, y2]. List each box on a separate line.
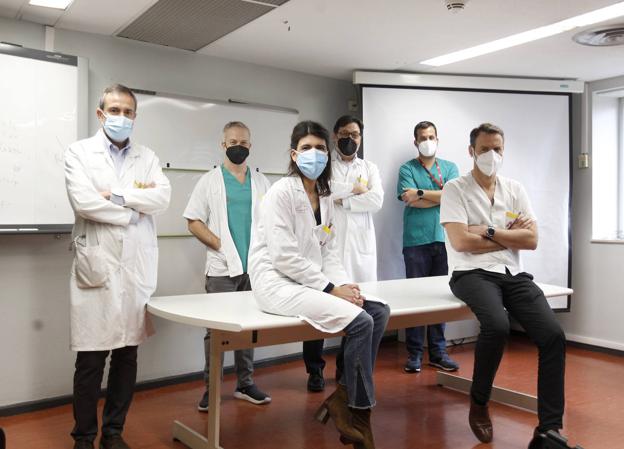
[132, 90, 298, 174]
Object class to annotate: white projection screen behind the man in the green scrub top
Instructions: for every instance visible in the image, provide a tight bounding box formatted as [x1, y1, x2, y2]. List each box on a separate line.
[362, 87, 571, 309]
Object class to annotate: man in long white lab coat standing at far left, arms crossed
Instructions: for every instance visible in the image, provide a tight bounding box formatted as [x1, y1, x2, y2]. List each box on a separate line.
[65, 84, 171, 449]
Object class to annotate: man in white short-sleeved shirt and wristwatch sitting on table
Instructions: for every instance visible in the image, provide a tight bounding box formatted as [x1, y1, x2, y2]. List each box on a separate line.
[440, 123, 565, 449]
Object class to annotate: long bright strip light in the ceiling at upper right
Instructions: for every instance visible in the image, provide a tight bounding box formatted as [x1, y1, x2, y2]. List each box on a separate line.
[421, 2, 624, 67]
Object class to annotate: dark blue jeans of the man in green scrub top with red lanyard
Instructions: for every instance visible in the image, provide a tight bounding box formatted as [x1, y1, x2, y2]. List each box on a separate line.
[403, 242, 448, 359]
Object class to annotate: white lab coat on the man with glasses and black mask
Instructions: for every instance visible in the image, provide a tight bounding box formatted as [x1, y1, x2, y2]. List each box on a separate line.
[331, 151, 384, 282]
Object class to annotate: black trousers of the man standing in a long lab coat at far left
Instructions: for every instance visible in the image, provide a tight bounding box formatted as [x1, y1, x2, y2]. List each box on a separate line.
[71, 346, 137, 441]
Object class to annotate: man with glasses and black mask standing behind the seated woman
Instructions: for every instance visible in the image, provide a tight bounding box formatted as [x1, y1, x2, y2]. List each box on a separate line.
[303, 115, 384, 392]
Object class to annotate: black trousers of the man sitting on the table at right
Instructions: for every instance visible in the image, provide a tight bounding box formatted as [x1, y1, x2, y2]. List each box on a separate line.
[450, 270, 565, 431]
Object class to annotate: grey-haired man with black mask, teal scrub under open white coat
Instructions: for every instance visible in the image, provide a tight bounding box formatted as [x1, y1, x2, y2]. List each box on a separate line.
[184, 122, 271, 412]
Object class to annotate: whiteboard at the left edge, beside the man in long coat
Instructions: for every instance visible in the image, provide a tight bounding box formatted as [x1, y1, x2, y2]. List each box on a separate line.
[0, 44, 86, 233]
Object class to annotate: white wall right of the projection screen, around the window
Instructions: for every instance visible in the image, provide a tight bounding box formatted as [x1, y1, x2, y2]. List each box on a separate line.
[559, 76, 624, 350]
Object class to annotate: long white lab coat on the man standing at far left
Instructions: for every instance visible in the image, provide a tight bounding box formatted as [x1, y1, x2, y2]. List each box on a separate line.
[65, 130, 171, 351]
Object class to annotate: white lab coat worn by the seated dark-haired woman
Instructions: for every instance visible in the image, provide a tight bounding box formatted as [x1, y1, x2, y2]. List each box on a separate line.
[249, 176, 362, 333]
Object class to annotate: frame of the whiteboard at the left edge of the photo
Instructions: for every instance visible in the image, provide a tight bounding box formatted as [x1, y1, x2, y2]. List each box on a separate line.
[0, 42, 89, 235]
